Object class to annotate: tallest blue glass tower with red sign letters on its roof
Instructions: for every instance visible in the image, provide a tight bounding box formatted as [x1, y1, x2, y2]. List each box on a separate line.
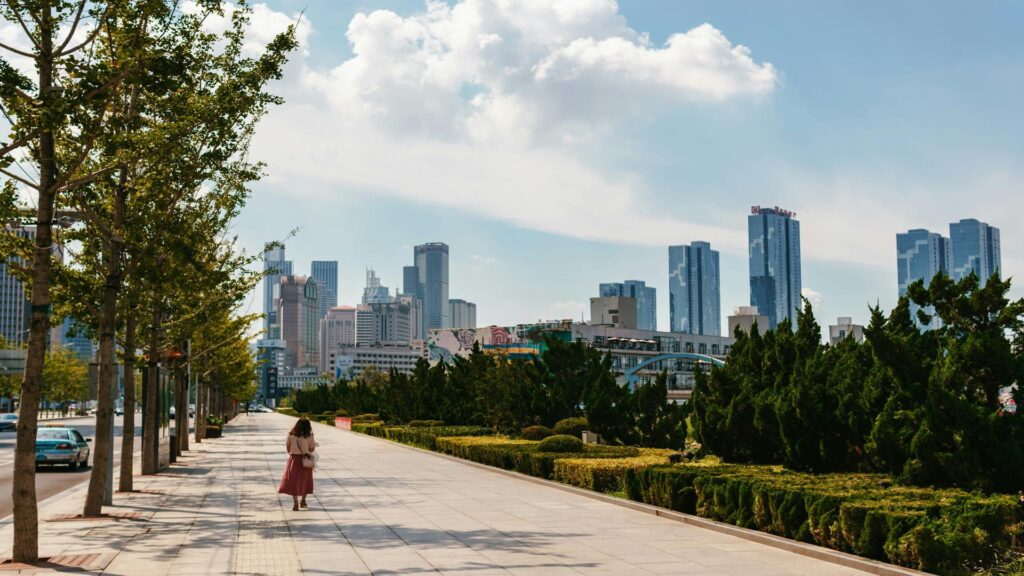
[746, 206, 802, 330]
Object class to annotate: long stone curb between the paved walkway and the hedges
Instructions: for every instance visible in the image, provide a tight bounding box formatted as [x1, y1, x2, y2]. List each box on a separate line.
[323, 416, 933, 576]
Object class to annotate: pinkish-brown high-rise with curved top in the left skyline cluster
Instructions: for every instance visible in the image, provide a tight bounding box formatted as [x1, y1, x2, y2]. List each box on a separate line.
[276, 276, 319, 369]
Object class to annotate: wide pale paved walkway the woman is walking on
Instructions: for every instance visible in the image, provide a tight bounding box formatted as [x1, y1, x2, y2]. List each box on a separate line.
[0, 414, 888, 576]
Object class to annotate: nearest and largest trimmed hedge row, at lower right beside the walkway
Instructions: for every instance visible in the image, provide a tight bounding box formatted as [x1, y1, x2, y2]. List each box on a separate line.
[626, 459, 1021, 574]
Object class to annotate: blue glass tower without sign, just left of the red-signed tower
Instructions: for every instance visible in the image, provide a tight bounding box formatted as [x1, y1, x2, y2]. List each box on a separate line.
[669, 242, 722, 336]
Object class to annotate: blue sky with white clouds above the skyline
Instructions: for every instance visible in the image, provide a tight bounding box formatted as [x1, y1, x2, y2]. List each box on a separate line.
[236, 0, 1024, 332]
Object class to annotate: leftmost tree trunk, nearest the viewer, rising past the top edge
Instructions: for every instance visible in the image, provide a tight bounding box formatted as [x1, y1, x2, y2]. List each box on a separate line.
[11, 1, 56, 563]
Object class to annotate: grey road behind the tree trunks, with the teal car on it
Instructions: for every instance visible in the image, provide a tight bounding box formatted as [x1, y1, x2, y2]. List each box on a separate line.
[0, 413, 190, 518]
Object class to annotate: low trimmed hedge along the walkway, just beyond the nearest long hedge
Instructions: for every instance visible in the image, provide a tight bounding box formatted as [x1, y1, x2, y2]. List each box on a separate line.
[437, 437, 639, 480]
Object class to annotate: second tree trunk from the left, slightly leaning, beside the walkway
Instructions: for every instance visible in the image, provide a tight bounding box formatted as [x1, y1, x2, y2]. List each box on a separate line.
[82, 166, 128, 517]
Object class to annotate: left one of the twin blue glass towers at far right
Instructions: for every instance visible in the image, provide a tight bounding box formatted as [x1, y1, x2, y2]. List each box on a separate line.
[896, 229, 953, 328]
